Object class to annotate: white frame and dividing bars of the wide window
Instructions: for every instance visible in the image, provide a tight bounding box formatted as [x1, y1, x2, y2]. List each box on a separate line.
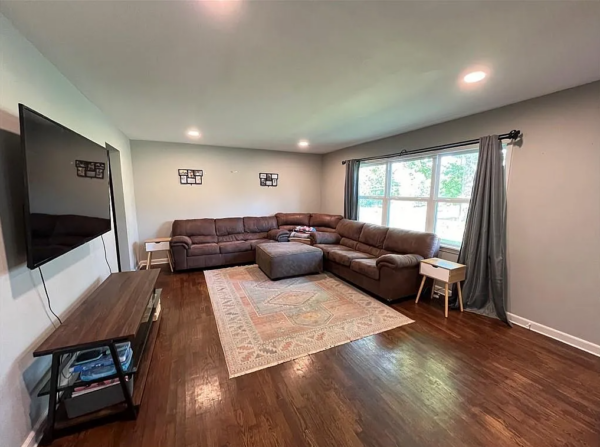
[358, 144, 482, 250]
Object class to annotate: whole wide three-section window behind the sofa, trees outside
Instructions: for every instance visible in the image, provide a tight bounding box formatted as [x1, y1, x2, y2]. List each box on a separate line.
[358, 148, 479, 248]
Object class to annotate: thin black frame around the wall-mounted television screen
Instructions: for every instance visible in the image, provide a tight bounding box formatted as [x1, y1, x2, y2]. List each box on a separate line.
[19, 103, 113, 270]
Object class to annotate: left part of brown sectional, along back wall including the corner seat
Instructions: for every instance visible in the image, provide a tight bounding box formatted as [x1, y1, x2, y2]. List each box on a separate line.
[171, 213, 342, 271]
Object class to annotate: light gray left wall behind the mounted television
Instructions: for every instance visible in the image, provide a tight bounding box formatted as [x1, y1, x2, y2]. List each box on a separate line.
[0, 14, 137, 447]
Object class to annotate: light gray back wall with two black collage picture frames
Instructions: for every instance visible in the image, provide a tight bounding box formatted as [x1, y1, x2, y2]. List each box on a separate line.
[131, 141, 321, 262]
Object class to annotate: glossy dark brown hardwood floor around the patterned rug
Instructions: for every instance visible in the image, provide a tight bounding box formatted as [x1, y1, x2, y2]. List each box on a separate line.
[53, 269, 600, 447]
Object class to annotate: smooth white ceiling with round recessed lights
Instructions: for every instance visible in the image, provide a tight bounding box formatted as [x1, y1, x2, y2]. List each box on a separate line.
[0, 0, 600, 153]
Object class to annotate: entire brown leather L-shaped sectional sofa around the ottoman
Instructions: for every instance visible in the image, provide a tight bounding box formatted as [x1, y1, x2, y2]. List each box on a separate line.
[171, 213, 440, 301]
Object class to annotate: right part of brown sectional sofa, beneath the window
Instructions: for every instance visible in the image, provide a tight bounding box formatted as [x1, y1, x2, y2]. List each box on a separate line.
[311, 219, 440, 301]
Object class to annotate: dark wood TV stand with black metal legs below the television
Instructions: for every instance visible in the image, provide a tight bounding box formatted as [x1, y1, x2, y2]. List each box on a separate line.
[33, 269, 160, 444]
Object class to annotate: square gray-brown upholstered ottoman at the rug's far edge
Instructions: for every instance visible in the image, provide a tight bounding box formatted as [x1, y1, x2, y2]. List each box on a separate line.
[256, 242, 323, 279]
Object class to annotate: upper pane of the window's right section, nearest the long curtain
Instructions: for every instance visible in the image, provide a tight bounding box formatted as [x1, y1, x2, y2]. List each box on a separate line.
[439, 152, 479, 199]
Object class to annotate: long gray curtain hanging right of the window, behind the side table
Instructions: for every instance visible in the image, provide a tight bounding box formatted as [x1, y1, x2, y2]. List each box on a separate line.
[452, 135, 508, 324]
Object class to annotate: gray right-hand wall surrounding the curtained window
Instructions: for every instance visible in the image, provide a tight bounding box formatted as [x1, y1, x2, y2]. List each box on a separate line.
[321, 82, 600, 344]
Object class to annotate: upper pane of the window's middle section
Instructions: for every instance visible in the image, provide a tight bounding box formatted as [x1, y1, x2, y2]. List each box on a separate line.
[391, 158, 433, 197]
